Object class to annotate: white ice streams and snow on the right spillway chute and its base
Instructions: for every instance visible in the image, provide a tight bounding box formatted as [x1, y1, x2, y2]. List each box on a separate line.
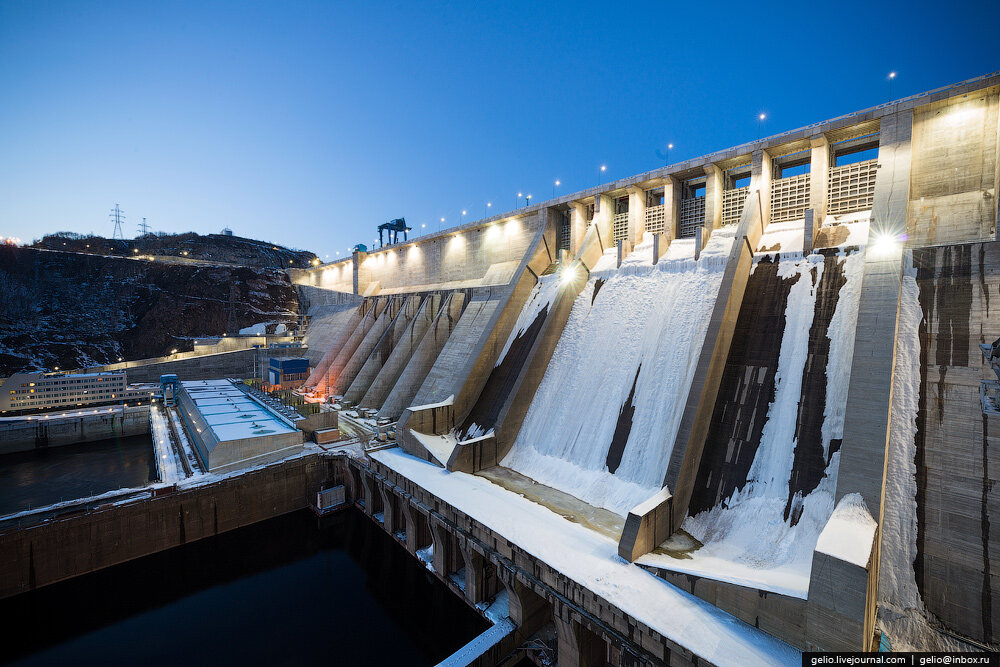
[638, 223, 867, 599]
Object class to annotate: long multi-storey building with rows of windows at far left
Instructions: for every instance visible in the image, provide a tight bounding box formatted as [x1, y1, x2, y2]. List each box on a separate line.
[0, 370, 159, 413]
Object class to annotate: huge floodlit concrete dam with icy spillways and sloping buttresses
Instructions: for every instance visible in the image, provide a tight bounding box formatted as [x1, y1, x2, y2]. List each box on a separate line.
[290, 74, 1000, 665]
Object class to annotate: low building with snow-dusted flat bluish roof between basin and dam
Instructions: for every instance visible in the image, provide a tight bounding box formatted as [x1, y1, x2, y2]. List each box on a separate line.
[174, 376, 303, 472]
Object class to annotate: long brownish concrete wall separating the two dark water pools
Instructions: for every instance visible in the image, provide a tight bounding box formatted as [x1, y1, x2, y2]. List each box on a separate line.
[0, 455, 347, 598]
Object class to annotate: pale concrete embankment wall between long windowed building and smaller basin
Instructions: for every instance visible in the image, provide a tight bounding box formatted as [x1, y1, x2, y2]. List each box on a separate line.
[0, 405, 149, 454]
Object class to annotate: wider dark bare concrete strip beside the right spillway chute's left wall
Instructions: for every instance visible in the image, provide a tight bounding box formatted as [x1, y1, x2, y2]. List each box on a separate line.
[689, 256, 799, 514]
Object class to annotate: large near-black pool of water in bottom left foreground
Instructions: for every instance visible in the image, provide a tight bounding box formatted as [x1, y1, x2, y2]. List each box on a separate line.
[0, 509, 487, 667]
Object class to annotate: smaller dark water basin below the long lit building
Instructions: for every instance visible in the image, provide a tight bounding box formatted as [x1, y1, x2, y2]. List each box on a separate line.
[0, 435, 156, 514]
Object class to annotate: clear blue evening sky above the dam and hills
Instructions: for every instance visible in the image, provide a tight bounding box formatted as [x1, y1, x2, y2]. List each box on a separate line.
[0, 0, 1000, 259]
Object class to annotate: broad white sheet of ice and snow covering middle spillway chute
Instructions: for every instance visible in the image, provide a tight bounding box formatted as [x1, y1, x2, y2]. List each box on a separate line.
[502, 226, 735, 516]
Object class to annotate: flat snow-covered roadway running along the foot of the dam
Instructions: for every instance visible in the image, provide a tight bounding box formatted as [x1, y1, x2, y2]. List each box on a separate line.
[370, 448, 802, 667]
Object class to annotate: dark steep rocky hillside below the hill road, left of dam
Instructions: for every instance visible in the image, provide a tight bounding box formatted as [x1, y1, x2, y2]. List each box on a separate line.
[0, 246, 298, 377]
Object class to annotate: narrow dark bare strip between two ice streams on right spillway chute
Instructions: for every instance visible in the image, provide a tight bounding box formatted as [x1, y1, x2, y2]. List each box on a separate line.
[784, 251, 847, 526]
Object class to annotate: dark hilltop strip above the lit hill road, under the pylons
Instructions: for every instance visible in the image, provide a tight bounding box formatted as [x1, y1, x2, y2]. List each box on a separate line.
[31, 232, 316, 268]
